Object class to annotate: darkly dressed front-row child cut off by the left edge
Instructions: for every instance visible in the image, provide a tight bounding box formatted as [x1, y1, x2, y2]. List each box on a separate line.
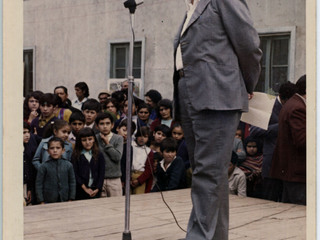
[23, 122, 41, 205]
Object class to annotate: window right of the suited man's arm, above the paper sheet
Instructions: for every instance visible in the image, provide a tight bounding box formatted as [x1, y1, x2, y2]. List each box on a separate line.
[255, 29, 295, 95]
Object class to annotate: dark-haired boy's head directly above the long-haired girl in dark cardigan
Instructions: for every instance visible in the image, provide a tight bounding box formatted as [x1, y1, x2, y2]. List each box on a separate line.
[81, 98, 101, 134]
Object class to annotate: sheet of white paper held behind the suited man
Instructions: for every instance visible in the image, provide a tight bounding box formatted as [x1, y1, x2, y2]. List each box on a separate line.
[241, 92, 276, 130]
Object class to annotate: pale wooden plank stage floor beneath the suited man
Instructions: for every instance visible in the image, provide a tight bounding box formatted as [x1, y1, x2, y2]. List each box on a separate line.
[24, 189, 306, 240]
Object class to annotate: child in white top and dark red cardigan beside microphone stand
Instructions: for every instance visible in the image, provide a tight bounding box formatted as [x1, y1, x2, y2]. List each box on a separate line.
[131, 127, 153, 194]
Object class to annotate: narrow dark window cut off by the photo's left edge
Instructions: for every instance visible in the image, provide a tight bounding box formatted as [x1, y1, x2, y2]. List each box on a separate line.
[23, 49, 35, 97]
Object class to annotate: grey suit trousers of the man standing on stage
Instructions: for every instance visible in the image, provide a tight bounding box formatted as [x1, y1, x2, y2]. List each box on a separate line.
[179, 78, 241, 240]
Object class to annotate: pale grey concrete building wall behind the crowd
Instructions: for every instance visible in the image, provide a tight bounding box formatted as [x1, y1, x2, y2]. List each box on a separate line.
[24, 0, 306, 99]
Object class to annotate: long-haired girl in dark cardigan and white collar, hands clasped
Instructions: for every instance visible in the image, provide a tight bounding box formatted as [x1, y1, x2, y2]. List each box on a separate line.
[72, 127, 105, 200]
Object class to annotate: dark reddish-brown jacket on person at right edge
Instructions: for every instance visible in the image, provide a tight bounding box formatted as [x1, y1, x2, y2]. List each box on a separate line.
[270, 94, 306, 182]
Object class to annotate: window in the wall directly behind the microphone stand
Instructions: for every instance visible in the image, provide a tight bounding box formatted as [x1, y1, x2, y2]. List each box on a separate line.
[108, 41, 144, 97]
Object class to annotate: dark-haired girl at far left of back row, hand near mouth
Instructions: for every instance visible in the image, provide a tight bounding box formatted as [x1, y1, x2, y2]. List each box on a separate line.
[23, 91, 43, 124]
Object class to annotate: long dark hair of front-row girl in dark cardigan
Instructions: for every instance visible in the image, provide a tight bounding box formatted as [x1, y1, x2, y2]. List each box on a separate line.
[72, 127, 99, 162]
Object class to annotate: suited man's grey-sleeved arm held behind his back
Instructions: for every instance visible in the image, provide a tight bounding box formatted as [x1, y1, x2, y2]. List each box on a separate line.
[218, 0, 262, 94]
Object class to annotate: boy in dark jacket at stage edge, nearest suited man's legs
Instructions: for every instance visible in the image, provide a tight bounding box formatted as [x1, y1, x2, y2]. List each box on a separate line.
[152, 138, 186, 192]
